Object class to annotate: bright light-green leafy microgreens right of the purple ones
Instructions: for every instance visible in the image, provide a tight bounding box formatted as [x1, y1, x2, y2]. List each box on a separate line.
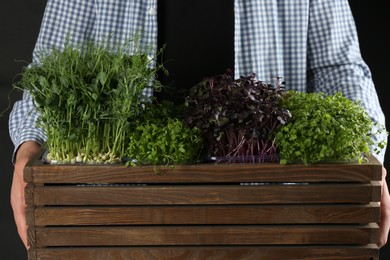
[276, 91, 384, 164]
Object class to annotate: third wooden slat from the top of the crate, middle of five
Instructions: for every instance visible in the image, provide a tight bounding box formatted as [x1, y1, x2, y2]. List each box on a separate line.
[35, 203, 380, 226]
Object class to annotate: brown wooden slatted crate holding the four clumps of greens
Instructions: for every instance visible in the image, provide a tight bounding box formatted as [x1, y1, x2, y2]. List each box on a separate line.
[25, 155, 381, 260]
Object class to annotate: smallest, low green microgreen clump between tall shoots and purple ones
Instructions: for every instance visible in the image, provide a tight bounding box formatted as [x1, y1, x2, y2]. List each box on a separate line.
[127, 101, 203, 165]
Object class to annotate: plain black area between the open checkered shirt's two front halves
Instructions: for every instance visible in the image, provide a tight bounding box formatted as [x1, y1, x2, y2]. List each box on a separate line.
[157, 0, 234, 103]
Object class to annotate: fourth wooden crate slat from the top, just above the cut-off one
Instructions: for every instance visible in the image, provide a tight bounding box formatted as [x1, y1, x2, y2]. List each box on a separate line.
[36, 224, 379, 247]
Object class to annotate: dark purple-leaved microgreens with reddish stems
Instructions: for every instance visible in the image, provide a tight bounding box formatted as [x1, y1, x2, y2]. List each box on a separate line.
[186, 73, 290, 161]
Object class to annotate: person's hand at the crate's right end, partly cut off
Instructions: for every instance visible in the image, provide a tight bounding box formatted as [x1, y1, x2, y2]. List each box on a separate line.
[378, 167, 390, 247]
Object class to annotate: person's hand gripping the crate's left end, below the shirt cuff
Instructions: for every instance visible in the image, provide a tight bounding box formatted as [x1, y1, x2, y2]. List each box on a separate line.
[11, 141, 40, 249]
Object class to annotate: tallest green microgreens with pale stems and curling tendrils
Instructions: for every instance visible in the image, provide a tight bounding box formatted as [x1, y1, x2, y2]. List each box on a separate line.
[15, 37, 165, 163]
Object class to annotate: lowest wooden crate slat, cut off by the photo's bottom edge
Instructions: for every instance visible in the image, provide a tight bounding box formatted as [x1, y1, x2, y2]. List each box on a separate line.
[31, 245, 379, 260]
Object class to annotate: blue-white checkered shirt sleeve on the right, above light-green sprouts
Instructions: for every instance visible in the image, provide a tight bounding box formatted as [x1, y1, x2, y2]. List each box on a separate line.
[308, 0, 387, 163]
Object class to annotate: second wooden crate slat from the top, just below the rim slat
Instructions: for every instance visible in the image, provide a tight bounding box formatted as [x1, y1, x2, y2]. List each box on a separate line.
[34, 182, 381, 206]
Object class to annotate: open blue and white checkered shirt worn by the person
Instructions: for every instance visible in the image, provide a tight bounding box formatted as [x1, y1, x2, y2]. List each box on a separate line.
[9, 0, 386, 162]
